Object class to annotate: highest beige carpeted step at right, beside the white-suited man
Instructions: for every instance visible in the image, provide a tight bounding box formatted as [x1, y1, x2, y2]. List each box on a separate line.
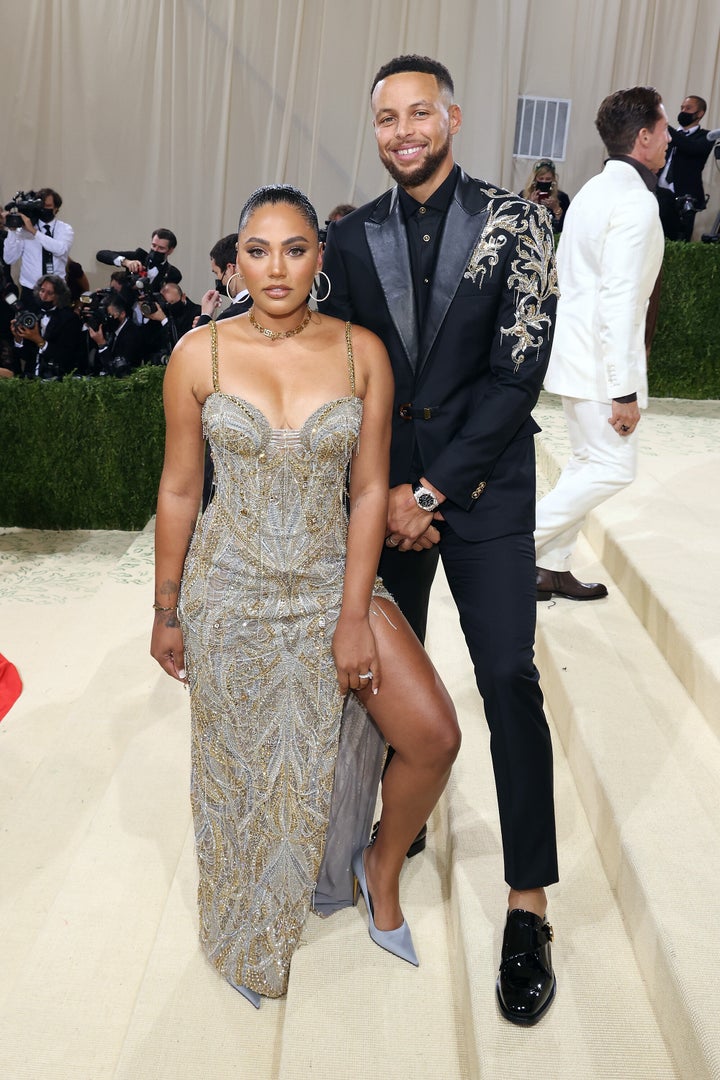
[535, 394, 720, 737]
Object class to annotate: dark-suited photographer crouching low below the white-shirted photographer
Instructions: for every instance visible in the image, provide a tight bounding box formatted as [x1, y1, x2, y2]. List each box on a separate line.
[11, 273, 84, 379]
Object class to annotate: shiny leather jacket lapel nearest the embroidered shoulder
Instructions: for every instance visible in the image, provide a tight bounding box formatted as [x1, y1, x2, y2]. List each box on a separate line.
[418, 191, 488, 370]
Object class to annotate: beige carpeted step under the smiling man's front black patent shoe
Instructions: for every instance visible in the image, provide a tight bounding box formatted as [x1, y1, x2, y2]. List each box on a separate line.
[429, 581, 680, 1080]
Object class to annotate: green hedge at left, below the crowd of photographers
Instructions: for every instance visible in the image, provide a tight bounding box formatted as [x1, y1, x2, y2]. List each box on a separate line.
[0, 367, 165, 529]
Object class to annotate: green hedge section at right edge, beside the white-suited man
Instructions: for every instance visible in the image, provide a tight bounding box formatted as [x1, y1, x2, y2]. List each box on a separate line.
[648, 241, 720, 399]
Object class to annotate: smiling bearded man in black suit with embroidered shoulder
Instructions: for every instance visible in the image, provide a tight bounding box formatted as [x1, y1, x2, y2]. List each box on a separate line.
[325, 56, 557, 1024]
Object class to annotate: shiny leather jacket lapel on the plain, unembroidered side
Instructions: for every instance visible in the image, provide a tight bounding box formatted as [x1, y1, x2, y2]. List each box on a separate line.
[365, 194, 420, 370]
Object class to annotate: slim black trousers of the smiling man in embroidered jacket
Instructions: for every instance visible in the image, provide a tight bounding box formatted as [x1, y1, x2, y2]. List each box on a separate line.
[380, 523, 558, 889]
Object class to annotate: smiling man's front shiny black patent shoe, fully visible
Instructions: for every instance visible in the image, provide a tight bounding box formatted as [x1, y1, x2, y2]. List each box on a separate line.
[495, 908, 556, 1026]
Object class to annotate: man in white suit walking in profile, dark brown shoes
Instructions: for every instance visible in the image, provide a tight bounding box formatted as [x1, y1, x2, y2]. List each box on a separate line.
[535, 86, 668, 600]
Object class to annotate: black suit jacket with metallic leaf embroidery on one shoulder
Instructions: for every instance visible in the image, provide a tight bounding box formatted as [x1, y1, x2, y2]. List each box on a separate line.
[324, 171, 557, 540]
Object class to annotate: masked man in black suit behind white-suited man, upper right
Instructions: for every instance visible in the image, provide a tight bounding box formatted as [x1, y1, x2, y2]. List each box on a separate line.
[657, 94, 712, 240]
